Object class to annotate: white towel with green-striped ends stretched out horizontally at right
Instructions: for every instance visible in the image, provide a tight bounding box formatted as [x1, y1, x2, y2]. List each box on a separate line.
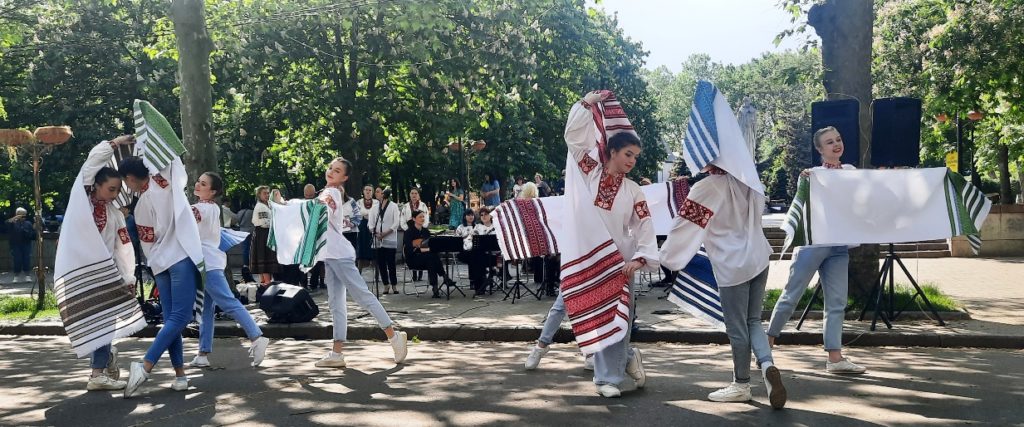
[781, 168, 992, 254]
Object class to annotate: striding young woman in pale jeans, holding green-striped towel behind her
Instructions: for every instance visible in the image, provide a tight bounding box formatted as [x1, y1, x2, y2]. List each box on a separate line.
[315, 158, 409, 368]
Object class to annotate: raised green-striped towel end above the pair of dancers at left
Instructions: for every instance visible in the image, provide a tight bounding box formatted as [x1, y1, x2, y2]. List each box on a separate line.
[132, 99, 185, 174]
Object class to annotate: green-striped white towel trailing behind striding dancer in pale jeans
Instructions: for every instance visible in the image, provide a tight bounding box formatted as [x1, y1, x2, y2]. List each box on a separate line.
[267, 200, 329, 269]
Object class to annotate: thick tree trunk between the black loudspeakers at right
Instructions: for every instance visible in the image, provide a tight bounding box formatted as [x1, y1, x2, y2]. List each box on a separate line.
[807, 0, 879, 300]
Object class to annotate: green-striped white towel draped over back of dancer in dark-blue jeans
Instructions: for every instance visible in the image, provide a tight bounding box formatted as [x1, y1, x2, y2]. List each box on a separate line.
[133, 99, 206, 322]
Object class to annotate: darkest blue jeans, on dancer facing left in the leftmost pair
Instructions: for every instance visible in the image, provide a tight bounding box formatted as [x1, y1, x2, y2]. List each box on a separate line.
[144, 258, 199, 368]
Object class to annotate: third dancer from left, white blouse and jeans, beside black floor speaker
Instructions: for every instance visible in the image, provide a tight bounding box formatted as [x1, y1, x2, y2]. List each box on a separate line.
[188, 172, 270, 368]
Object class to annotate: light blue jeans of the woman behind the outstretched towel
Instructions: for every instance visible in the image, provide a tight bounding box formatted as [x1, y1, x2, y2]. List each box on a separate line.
[768, 246, 850, 351]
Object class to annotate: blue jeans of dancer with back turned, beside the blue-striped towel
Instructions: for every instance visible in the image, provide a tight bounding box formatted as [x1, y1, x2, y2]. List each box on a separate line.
[719, 268, 774, 383]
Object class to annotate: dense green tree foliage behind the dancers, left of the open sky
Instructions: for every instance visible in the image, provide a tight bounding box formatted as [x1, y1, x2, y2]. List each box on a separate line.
[0, 0, 665, 210]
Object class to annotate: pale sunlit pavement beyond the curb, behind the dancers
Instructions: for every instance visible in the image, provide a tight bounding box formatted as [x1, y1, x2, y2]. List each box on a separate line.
[0, 258, 1024, 348]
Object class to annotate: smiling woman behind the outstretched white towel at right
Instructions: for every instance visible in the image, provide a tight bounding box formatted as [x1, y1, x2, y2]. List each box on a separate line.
[768, 126, 867, 374]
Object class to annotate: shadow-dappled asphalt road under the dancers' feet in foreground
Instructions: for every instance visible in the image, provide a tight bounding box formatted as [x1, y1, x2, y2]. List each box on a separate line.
[0, 337, 1024, 427]
